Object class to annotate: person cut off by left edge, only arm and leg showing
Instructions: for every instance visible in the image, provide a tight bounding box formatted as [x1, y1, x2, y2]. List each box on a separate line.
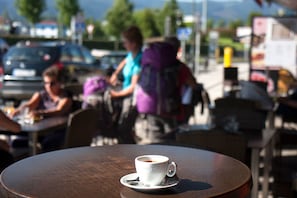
[0, 111, 21, 172]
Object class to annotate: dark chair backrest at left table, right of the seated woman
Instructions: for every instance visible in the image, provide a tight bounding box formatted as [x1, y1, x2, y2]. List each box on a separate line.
[64, 109, 99, 148]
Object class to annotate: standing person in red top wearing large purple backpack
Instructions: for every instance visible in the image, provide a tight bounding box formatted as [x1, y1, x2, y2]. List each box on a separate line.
[135, 39, 197, 144]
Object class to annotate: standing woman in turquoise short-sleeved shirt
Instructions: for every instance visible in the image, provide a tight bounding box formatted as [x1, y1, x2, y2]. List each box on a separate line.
[109, 26, 143, 143]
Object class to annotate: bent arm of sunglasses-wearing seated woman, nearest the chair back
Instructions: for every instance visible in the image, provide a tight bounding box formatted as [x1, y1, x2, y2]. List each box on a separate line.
[32, 97, 72, 117]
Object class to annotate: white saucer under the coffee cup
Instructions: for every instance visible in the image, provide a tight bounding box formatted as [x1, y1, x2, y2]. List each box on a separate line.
[120, 173, 179, 191]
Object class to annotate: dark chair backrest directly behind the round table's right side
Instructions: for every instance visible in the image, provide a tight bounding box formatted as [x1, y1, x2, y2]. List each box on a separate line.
[176, 129, 247, 163]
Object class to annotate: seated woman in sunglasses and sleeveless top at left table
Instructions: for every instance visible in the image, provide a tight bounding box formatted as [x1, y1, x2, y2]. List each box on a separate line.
[13, 66, 72, 151]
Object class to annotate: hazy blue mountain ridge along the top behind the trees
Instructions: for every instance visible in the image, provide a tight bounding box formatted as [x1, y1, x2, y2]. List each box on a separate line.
[0, 0, 280, 21]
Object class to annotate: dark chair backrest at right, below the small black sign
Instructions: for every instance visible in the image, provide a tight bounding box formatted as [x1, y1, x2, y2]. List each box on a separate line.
[212, 98, 267, 132]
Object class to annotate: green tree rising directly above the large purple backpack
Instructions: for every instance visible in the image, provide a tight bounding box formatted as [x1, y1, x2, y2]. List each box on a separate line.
[157, 0, 180, 35]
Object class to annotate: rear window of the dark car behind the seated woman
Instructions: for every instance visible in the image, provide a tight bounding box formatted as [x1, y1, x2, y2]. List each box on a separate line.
[6, 47, 57, 62]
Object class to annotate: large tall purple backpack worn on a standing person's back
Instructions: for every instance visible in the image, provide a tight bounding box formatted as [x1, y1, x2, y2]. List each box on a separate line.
[136, 42, 181, 115]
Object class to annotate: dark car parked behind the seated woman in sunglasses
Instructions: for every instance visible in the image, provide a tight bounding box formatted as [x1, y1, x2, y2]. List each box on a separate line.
[0, 41, 102, 100]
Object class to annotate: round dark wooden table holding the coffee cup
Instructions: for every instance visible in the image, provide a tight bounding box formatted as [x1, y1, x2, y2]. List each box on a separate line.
[0, 145, 252, 198]
